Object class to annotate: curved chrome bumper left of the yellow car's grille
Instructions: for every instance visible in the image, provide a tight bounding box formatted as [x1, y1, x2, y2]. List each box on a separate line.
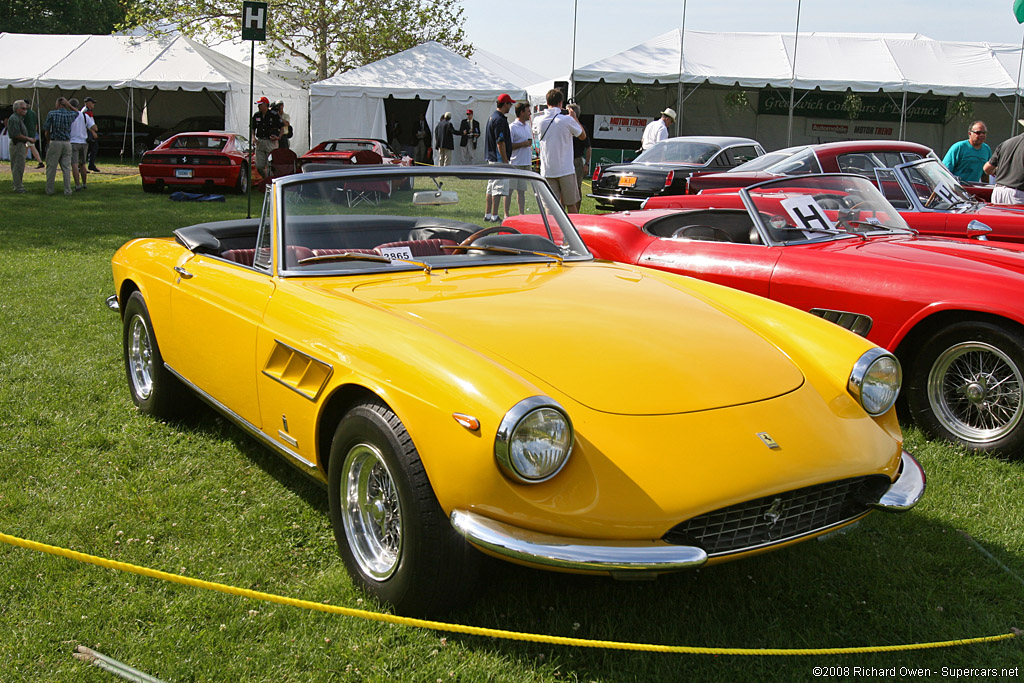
[451, 510, 708, 572]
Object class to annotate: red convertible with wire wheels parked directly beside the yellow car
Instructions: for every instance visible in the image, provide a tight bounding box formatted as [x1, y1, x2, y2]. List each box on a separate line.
[557, 174, 1024, 454]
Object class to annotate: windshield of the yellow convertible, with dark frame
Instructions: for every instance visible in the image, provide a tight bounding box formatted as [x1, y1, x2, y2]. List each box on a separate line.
[270, 167, 591, 275]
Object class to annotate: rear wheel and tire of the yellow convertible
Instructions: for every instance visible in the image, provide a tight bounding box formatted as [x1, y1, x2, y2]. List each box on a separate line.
[122, 292, 191, 418]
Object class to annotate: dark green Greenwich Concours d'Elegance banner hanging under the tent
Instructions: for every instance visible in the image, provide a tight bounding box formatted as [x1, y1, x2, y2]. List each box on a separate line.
[758, 88, 946, 124]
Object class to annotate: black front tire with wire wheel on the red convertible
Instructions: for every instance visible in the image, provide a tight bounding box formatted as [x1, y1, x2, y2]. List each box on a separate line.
[907, 322, 1024, 455]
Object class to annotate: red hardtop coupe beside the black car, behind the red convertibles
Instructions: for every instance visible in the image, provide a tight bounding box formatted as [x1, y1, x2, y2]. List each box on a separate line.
[687, 140, 992, 201]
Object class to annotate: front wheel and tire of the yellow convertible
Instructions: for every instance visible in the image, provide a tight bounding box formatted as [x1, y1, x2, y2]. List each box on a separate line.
[328, 400, 479, 616]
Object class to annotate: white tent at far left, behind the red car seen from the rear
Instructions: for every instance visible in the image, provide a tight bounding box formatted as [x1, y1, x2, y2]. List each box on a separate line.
[0, 33, 309, 153]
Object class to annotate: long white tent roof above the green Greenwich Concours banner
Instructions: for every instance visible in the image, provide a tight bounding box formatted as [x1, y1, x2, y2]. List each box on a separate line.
[573, 29, 1021, 97]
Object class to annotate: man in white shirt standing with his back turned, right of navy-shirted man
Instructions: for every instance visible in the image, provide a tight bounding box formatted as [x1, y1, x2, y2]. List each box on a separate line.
[534, 89, 587, 213]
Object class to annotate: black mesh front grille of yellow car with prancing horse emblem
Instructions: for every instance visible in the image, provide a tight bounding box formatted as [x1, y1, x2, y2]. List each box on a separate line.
[663, 474, 891, 556]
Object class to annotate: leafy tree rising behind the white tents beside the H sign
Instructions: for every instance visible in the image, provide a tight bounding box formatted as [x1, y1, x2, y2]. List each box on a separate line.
[118, 0, 473, 80]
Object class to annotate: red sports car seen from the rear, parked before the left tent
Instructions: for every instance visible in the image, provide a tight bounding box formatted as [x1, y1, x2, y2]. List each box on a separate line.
[138, 131, 251, 194]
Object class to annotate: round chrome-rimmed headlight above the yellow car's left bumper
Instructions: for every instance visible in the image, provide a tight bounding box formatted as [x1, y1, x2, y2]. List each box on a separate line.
[495, 396, 572, 483]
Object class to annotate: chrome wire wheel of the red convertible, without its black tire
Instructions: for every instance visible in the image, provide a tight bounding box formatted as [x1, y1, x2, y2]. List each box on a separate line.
[928, 341, 1024, 443]
